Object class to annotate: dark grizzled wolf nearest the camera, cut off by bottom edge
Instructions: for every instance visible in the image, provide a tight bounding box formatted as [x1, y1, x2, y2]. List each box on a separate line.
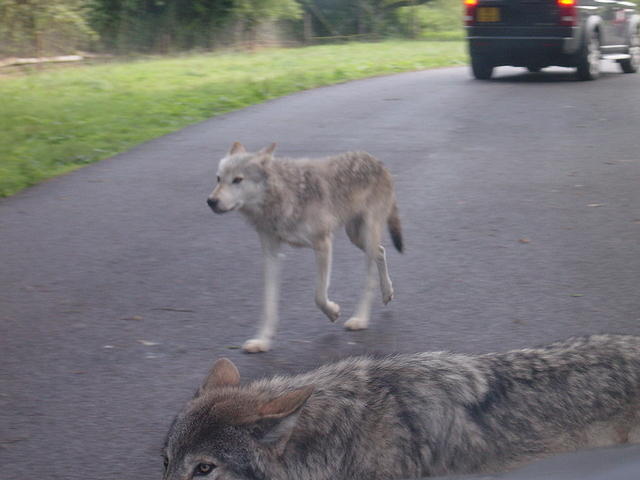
[164, 335, 640, 480]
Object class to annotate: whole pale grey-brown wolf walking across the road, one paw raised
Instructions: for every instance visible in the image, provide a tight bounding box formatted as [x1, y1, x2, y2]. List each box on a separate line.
[207, 142, 402, 352]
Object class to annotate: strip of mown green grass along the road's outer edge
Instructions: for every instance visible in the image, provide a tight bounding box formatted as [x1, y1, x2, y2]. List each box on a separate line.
[0, 41, 466, 196]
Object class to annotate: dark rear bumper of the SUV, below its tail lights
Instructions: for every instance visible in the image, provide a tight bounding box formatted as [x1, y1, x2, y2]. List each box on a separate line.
[467, 27, 580, 66]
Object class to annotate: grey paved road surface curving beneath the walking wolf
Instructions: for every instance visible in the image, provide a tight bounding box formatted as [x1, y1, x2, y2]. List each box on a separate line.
[0, 66, 640, 480]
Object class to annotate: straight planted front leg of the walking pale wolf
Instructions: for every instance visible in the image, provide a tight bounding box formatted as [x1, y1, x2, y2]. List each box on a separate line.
[242, 236, 281, 353]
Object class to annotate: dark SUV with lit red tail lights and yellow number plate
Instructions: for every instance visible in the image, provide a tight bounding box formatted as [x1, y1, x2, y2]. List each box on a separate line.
[464, 0, 640, 80]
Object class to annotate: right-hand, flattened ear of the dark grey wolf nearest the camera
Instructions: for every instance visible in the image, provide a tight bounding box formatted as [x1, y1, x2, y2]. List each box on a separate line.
[254, 385, 315, 455]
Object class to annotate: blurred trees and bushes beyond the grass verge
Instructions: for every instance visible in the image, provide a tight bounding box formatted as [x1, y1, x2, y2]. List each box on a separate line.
[0, 0, 462, 57]
